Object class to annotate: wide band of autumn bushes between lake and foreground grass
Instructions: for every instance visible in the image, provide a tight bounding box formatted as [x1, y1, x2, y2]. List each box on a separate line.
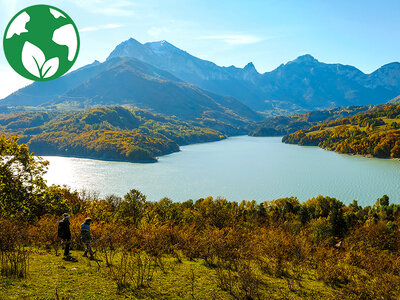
[0, 191, 400, 299]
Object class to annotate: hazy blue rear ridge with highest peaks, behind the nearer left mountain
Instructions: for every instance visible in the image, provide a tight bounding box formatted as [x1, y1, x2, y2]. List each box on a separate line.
[109, 39, 400, 111]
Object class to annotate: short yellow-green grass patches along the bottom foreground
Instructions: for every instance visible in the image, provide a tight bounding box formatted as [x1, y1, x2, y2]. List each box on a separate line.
[0, 250, 337, 299]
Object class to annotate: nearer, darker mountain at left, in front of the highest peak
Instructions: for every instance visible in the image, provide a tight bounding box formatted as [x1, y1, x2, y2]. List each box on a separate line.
[3, 57, 261, 125]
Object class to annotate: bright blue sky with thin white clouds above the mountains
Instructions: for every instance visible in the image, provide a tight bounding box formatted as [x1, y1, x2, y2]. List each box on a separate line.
[0, 0, 400, 98]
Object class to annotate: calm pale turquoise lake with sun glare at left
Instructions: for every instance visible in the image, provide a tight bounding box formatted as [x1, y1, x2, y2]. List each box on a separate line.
[44, 136, 400, 205]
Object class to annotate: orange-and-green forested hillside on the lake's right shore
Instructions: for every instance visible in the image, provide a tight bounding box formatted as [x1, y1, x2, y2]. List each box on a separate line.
[282, 104, 400, 158]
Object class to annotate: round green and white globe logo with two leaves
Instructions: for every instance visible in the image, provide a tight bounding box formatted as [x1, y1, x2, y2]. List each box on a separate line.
[3, 5, 79, 81]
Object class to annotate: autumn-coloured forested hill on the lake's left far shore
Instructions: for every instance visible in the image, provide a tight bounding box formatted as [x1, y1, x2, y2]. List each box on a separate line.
[0, 106, 227, 162]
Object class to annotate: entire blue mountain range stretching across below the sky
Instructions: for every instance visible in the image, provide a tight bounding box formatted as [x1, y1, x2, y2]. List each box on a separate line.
[0, 38, 400, 118]
